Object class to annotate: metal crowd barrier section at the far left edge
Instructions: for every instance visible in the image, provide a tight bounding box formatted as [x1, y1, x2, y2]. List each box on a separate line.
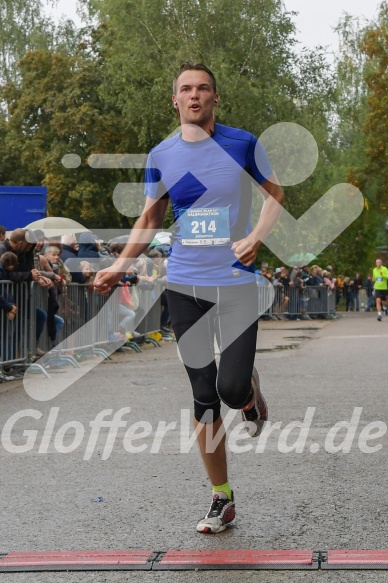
[0, 281, 30, 369]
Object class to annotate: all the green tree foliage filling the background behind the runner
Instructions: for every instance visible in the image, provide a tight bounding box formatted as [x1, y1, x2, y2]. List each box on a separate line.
[0, 0, 388, 273]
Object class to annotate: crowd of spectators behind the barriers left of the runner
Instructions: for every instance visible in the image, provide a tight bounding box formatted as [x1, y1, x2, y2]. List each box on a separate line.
[0, 227, 171, 362]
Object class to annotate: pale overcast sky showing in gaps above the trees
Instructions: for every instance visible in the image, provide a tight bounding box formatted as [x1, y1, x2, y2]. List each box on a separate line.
[48, 0, 381, 52]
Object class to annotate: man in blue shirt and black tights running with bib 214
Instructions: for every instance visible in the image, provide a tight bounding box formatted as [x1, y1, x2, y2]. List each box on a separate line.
[94, 63, 283, 533]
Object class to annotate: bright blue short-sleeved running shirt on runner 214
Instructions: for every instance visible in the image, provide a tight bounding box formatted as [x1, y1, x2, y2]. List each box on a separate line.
[145, 123, 272, 286]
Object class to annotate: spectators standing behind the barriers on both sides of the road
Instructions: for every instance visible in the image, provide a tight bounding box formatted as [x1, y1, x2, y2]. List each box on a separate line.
[0, 226, 388, 362]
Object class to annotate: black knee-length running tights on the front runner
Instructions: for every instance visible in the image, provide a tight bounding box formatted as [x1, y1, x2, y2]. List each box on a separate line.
[167, 283, 258, 423]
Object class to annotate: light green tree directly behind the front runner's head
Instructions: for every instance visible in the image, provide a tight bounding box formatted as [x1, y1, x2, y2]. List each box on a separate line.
[80, 0, 295, 152]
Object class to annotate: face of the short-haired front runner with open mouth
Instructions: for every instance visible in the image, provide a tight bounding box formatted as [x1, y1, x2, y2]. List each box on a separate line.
[173, 71, 218, 129]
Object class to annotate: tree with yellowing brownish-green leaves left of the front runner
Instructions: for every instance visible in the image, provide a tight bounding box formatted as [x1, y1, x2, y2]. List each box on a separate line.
[0, 44, 139, 227]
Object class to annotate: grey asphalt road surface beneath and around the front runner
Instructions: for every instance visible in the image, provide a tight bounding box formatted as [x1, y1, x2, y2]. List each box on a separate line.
[0, 312, 388, 583]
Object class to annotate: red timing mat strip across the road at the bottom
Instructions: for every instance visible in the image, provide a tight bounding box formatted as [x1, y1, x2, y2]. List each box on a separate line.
[6, 549, 388, 573]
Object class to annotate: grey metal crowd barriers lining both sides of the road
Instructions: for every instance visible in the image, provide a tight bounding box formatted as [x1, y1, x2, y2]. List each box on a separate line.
[0, 282, 336, 365]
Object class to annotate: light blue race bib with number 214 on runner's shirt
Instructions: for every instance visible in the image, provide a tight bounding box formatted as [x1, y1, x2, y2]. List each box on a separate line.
[179, 207, 230, 245]
